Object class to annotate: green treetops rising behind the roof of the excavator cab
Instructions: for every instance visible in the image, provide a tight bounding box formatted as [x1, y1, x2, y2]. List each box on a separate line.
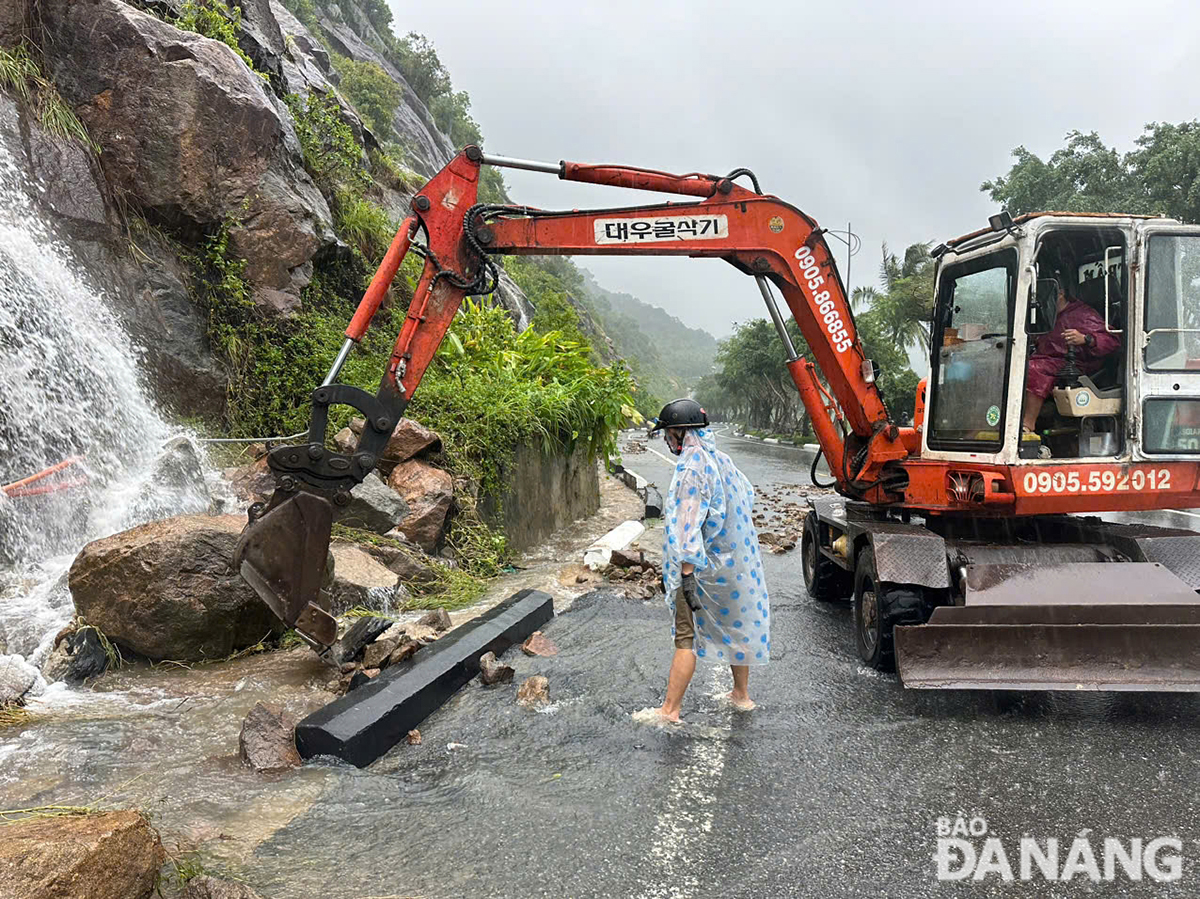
[979, 120, 1200, 222]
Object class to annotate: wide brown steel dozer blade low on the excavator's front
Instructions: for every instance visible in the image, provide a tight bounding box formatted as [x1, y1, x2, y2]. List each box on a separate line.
[894, 563, 1200, 693]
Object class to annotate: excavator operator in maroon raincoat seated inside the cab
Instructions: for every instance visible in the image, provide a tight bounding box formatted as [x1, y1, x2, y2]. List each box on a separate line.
[1021, 266, 1121, 459]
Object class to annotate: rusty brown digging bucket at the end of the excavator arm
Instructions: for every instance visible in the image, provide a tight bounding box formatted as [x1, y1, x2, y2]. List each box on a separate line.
[234, 492, 337, 648]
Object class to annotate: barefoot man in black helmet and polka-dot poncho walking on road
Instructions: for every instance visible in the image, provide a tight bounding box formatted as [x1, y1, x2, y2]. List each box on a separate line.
[652, 400, 770, 721]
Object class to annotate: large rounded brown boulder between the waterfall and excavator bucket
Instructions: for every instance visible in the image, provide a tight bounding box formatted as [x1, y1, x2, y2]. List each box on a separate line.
[70, 515, 280, 661]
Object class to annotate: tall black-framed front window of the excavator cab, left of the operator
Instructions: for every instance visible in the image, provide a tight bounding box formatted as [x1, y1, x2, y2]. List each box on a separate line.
[929, 250, 1018, 453]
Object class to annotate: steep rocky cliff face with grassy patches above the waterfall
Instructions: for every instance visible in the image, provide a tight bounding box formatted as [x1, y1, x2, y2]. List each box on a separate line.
[0, 0, 534, 420]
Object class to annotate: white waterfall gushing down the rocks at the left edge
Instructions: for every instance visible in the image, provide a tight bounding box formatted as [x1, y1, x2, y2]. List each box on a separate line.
[0, 144, 208, 660]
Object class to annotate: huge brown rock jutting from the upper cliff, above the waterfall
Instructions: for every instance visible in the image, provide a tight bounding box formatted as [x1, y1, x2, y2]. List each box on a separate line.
[40, 0, 335, 313]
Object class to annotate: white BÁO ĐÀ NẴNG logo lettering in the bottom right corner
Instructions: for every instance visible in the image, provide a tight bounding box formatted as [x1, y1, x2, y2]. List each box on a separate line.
[934, 815, 1183, 883]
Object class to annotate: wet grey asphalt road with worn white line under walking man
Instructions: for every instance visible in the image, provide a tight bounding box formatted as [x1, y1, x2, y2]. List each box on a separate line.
[251, 438, 1200, 899]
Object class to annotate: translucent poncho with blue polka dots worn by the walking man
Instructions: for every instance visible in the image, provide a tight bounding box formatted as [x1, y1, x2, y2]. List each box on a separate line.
[662, 427, 770, 665]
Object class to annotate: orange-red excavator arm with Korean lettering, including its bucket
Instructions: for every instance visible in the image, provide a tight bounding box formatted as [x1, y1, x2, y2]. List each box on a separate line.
[235, 146, 919, 647]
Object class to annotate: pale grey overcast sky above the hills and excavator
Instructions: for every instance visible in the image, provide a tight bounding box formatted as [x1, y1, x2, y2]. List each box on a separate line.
[390, 0, 1200, 336]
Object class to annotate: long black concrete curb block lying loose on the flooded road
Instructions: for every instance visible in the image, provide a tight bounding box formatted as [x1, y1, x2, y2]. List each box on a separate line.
[296, 591, 554, 768]
